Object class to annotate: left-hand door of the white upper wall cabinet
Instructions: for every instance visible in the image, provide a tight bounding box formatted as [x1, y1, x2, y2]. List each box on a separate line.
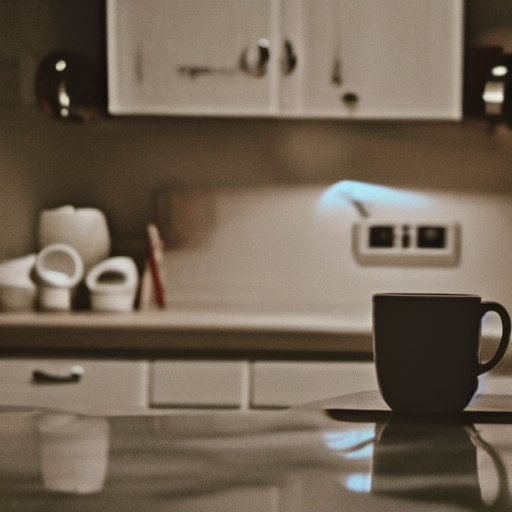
[107, 0, 279, 115]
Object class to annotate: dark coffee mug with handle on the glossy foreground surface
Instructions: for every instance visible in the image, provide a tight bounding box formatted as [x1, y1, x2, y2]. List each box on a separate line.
[373, 293, 511, 413]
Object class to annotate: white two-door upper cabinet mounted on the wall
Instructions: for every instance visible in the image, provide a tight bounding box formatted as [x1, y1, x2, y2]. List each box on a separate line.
[107, 0, 463, 119]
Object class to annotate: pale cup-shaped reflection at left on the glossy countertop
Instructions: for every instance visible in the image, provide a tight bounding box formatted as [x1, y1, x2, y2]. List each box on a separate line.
[37, 414, 109, 494]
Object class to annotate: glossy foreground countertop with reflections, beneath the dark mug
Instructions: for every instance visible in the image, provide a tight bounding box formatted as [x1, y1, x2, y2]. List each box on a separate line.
[0, 396, 512, 512]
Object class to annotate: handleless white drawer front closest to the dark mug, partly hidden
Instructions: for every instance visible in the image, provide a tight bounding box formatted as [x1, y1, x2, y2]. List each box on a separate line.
[251, 361, 378, 407]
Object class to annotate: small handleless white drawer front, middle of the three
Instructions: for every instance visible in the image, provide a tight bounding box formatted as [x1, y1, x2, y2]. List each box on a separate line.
[150, 360, 248, 407]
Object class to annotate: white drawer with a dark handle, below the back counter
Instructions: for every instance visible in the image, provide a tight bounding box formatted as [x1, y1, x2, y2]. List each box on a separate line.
[0, 359, 149, 413]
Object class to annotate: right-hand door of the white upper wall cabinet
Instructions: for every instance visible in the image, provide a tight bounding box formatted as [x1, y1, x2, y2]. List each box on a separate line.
[281, 0, 463, 119]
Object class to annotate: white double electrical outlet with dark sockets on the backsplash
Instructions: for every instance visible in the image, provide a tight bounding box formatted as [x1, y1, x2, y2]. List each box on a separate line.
[353, 220, 460, 267]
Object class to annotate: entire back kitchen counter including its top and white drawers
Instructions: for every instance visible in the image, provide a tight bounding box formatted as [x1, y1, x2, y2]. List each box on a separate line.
[0, 310, 512, 410]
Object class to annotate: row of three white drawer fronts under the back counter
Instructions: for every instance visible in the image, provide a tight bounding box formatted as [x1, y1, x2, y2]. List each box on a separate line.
[0, 358, 378, 414]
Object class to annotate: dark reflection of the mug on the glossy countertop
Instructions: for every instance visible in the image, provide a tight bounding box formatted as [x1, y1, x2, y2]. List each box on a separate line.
[347, 416, 512, 510]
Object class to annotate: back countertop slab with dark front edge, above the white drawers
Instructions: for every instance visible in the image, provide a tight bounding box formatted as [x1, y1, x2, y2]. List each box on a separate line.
[0, 310, 372, 359]
